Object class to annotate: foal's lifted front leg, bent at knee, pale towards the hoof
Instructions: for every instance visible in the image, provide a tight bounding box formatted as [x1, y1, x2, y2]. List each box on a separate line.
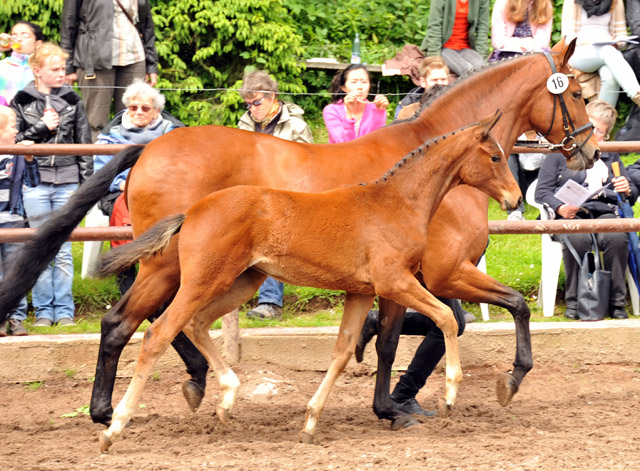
[376, 276, 462, 416]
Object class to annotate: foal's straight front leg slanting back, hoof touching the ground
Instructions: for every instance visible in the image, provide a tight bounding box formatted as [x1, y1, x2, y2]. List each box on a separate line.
[300, 293, 375, 443]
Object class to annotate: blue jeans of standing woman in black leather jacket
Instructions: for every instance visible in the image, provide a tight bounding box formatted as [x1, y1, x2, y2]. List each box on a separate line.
[22, 183, 78, 322]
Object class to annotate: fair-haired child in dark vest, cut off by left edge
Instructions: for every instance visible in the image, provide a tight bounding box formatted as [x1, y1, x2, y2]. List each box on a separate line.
[0, 106, 40, 337]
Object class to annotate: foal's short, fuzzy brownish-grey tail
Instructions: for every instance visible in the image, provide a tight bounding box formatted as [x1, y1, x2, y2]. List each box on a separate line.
[98, 214, 187, 276]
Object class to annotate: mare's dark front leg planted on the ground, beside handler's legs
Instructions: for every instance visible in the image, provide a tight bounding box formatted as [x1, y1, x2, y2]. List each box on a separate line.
[373, 298, 419, 430]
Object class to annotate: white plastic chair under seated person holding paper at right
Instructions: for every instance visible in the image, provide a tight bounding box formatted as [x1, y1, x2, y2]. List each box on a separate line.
[526, 180, 640, 317]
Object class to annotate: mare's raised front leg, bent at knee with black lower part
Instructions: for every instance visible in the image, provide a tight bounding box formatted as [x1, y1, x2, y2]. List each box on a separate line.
[429, 261, 533, 406]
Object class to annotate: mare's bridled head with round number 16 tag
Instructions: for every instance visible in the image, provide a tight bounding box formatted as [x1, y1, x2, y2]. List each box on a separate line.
[530, 39, 600, 170]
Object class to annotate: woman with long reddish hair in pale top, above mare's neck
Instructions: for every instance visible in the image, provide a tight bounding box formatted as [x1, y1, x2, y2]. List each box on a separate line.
[491, 0, 553, 57]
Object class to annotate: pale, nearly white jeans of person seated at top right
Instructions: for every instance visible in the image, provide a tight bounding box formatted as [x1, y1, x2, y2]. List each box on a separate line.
[569, 45, 640, 106]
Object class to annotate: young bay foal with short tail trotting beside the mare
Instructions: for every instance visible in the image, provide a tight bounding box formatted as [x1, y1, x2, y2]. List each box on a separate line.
[100, 113, 522, 451]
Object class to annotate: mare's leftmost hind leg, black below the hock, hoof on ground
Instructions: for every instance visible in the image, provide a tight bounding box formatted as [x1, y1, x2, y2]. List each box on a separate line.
[91, 265, 179, 425]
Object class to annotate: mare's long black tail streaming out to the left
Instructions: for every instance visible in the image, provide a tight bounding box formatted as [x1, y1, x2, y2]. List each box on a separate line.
[0, 146, 144, 323]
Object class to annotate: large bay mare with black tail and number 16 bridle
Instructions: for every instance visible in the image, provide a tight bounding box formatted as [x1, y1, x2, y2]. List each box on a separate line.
[0, 41, 599, 432]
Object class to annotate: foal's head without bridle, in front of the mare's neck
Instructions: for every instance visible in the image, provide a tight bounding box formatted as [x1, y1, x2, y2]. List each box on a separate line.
[460, 111, 522, 211]
